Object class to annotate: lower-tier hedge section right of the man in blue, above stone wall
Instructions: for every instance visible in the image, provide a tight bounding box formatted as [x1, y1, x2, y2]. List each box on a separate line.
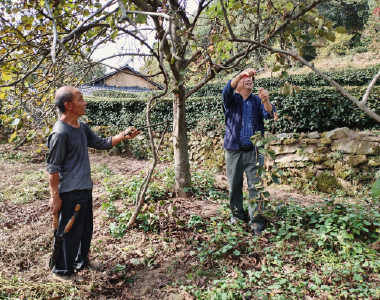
[267, 86, 380, 132]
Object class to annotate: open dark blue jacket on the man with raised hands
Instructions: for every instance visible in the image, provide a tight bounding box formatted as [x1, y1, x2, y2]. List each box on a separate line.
[222, 80, 276, 150]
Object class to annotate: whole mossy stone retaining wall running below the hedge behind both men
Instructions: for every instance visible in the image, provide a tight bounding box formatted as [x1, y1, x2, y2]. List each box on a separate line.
[90, 127, 380, 196]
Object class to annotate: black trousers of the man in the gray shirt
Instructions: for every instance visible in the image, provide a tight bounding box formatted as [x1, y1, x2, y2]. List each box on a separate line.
[53, 190, 93, 275]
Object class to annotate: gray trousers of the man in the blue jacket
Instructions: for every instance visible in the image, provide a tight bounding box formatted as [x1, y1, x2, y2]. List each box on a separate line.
[225, 149, 265, 230]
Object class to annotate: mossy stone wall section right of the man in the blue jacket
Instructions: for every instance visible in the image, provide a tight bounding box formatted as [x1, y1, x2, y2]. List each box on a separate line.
[266, 127, 380, 196]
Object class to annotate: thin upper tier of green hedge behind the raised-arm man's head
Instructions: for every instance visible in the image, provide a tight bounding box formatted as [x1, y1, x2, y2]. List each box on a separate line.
[194, 64, 380, 97]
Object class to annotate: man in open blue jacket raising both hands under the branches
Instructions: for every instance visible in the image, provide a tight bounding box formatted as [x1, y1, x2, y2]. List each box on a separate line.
[223, 69, 276, 235]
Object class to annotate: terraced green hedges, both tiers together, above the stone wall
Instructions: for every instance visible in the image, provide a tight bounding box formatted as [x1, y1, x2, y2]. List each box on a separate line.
[86, 66, 380, 135]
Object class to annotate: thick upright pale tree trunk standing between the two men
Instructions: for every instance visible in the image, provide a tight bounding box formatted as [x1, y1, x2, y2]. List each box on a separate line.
[173, 86, 191, 197]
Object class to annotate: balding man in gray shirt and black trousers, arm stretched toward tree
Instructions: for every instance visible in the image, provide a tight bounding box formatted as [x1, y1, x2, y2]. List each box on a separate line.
[46, 86, 140, 281]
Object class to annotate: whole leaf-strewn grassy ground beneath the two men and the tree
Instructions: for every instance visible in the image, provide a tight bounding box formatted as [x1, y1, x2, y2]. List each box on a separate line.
[0, 145, 380, 300]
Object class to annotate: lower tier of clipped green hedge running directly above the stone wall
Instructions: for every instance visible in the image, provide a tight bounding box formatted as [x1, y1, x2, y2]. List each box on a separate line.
[85, 87, 380, 134]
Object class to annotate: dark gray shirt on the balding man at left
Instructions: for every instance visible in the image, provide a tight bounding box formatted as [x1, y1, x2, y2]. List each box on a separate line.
[46, 120, 112, 193]
